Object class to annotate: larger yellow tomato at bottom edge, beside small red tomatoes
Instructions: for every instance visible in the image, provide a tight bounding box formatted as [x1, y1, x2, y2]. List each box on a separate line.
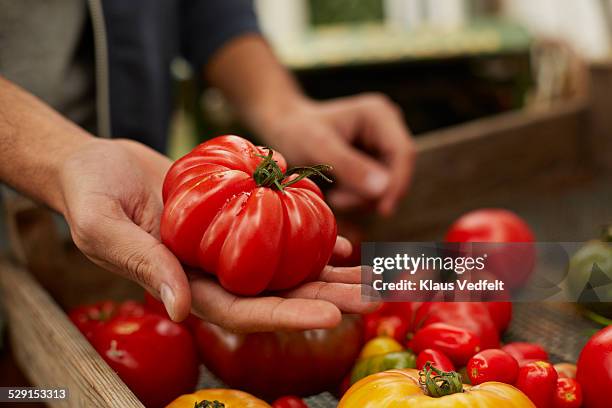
[338, 369, 535, 408]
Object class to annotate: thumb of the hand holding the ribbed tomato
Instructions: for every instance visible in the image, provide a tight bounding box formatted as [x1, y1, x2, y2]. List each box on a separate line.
[75, 217, 191, 321]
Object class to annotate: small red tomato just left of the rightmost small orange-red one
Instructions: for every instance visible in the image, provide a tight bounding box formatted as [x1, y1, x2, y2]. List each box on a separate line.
[515, 361, 557, 408]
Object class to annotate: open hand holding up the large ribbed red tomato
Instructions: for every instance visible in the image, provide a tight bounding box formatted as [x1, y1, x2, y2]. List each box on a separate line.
[60, 139, 375, 331]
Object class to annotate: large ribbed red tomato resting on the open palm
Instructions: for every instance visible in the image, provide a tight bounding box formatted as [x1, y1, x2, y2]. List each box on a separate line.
[161, 135, 336, 295]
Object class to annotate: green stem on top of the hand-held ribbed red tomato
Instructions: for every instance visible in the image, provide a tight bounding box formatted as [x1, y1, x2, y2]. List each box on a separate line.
[253, 147, 332, 191]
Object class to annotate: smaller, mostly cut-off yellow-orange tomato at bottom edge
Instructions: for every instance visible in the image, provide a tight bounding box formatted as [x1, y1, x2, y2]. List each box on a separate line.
[166, 388, 270, 408]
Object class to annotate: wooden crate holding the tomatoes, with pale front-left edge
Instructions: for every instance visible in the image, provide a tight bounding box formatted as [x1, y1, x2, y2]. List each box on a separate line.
[0, 62, 598, 407]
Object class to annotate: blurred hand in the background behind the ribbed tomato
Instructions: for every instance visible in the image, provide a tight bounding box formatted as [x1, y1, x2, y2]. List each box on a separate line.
[261, 94, 415, 215]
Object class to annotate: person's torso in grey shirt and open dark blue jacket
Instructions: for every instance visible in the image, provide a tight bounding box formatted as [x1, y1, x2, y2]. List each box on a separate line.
[0, 0, 179, 151]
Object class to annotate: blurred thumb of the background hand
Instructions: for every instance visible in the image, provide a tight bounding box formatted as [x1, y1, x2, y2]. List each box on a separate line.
[319, 136, 390, 199]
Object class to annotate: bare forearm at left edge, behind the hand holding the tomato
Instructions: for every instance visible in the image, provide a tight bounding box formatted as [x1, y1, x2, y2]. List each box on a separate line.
[0, 76, 93, 212]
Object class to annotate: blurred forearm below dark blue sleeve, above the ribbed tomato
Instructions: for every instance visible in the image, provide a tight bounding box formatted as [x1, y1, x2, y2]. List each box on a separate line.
[205, 34, 309, 142]
